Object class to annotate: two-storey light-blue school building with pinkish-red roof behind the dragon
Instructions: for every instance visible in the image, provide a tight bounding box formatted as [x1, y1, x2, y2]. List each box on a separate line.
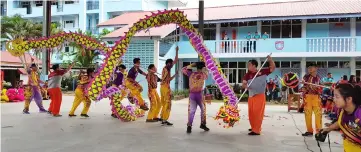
[98, 0, 361, 94]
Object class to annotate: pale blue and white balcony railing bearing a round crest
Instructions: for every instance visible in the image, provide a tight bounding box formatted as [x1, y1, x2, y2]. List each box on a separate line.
[174, 37, 361, 54]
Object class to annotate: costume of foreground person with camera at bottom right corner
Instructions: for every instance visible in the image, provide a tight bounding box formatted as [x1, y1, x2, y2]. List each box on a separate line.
[338, 107, 361, 152]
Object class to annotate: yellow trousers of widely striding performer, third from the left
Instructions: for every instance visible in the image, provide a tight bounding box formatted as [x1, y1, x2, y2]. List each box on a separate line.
[69, 88, 91, 115]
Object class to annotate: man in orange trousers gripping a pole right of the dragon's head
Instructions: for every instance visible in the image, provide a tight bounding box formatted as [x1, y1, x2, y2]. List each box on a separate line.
[242, 56, 276, 135]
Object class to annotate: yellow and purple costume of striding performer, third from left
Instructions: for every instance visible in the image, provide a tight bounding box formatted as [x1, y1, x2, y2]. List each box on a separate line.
[69, 75, 91, 116]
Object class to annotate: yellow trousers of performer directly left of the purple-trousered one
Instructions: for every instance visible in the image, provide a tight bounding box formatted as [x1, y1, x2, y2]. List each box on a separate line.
[160, 85, 172, 121]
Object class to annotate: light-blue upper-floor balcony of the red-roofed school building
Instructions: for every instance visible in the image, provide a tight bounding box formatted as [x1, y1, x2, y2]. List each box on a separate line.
[178, 37, 361, 58]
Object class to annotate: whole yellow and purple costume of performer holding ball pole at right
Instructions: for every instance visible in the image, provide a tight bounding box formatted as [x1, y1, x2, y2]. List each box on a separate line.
[303, 74, 322, 133]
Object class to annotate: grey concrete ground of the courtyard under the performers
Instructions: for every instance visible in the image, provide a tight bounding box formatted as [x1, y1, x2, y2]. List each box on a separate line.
[1, 96, 343, 152]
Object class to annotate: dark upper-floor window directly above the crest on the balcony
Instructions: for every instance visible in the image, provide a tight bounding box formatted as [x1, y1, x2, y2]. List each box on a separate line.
[261, 20, 302, 38]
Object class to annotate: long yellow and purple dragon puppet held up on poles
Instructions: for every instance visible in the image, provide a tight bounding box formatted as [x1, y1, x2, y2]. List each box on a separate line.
[8, 9, 239, 127]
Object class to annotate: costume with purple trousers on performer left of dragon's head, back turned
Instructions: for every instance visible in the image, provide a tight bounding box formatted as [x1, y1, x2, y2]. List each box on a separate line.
[182, 65, 208, 126]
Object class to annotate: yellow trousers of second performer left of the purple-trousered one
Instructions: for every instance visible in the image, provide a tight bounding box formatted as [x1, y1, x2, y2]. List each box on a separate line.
[147, 89, 161, 120]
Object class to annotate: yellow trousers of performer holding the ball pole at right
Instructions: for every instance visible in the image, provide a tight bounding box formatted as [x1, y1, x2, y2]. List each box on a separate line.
[304, 94, 322, 133]
